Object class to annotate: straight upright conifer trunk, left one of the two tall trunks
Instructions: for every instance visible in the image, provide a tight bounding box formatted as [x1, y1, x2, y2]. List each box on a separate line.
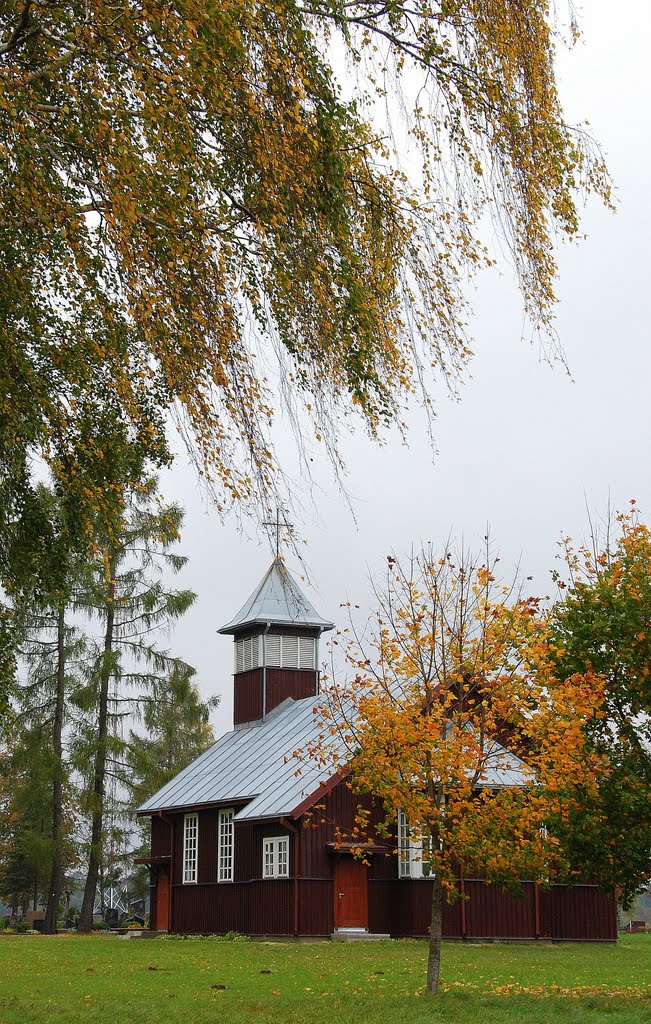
[43, 604, 66, 935]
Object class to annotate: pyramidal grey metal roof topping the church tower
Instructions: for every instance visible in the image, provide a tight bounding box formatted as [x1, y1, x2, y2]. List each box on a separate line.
[218, 558, 335, 633]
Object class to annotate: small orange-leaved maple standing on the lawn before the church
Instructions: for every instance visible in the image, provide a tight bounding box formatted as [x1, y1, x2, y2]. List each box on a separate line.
[307, 550, 605, 992]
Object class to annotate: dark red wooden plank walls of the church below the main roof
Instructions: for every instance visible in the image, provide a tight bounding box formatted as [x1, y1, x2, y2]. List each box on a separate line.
[146, 783, 616, 940]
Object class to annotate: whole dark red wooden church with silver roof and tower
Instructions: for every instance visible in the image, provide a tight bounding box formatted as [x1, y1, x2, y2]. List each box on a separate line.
[138, 558, 616, 940]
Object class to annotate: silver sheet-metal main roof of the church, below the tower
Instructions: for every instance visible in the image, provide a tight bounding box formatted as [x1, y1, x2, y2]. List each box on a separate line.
[138, 697, 530, 821]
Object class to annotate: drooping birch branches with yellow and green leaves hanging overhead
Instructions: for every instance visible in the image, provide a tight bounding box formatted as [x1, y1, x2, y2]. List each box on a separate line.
[0, 0, 608, 536]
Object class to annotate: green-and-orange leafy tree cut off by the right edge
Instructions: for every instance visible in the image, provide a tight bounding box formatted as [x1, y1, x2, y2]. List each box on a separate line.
[554, 502, 651, 906]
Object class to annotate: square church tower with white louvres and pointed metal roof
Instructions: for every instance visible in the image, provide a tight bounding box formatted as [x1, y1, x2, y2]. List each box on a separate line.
[219, 557, 334, 727]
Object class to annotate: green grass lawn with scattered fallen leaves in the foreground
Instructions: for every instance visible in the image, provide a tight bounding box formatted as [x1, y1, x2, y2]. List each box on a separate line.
[0, 935, 651, 1024]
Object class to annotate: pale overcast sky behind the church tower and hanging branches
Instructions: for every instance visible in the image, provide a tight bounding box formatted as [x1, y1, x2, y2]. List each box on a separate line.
[157, 0, 651, 733]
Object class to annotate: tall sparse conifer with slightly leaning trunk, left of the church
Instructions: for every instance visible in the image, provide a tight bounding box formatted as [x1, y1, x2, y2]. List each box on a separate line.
[77, 480, 194, 932]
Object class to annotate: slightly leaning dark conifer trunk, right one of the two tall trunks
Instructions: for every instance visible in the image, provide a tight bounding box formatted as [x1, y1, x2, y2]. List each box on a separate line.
[77, 577, 116, 933]
